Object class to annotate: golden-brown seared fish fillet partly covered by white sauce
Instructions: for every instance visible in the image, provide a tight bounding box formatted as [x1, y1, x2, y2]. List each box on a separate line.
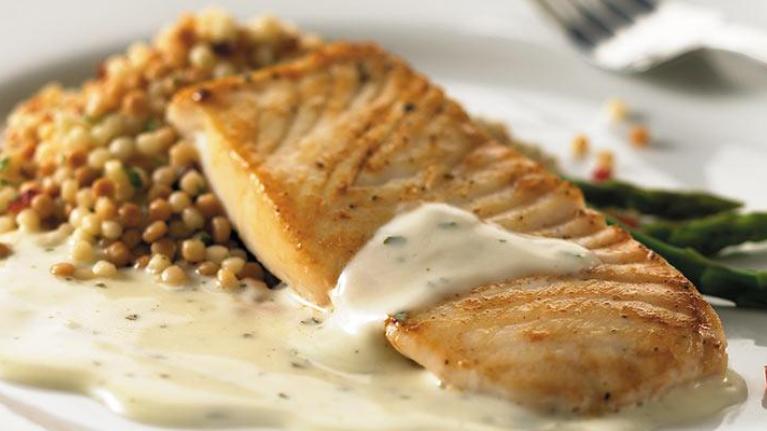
[169, 43, 727, 412]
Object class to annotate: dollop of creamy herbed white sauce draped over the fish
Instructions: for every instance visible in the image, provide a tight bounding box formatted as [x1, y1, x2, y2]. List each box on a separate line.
[330, 203, 599, 344]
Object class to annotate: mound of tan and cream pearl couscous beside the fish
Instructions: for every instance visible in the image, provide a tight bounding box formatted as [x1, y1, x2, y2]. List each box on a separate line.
[0, 9, 319, 289]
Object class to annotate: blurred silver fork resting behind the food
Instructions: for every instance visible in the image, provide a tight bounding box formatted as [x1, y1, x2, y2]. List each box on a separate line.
[536, 0, 767, 72]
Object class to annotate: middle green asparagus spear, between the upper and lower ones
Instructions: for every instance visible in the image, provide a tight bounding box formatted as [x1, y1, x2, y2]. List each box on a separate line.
[641, 212, 767, 256]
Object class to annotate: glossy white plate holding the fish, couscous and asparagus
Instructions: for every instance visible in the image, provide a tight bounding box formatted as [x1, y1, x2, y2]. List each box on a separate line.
[0, 0, 767, 431]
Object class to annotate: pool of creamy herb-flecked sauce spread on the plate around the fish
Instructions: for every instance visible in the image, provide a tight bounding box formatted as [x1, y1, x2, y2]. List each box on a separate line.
[0, 226, 745, 431]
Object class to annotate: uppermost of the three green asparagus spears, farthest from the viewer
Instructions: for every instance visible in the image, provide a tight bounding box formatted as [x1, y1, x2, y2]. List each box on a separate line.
[569, 179, 743, 220]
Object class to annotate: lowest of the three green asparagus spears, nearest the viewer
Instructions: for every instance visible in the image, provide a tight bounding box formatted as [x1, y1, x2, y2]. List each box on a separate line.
[611, 220, 767, 308]
